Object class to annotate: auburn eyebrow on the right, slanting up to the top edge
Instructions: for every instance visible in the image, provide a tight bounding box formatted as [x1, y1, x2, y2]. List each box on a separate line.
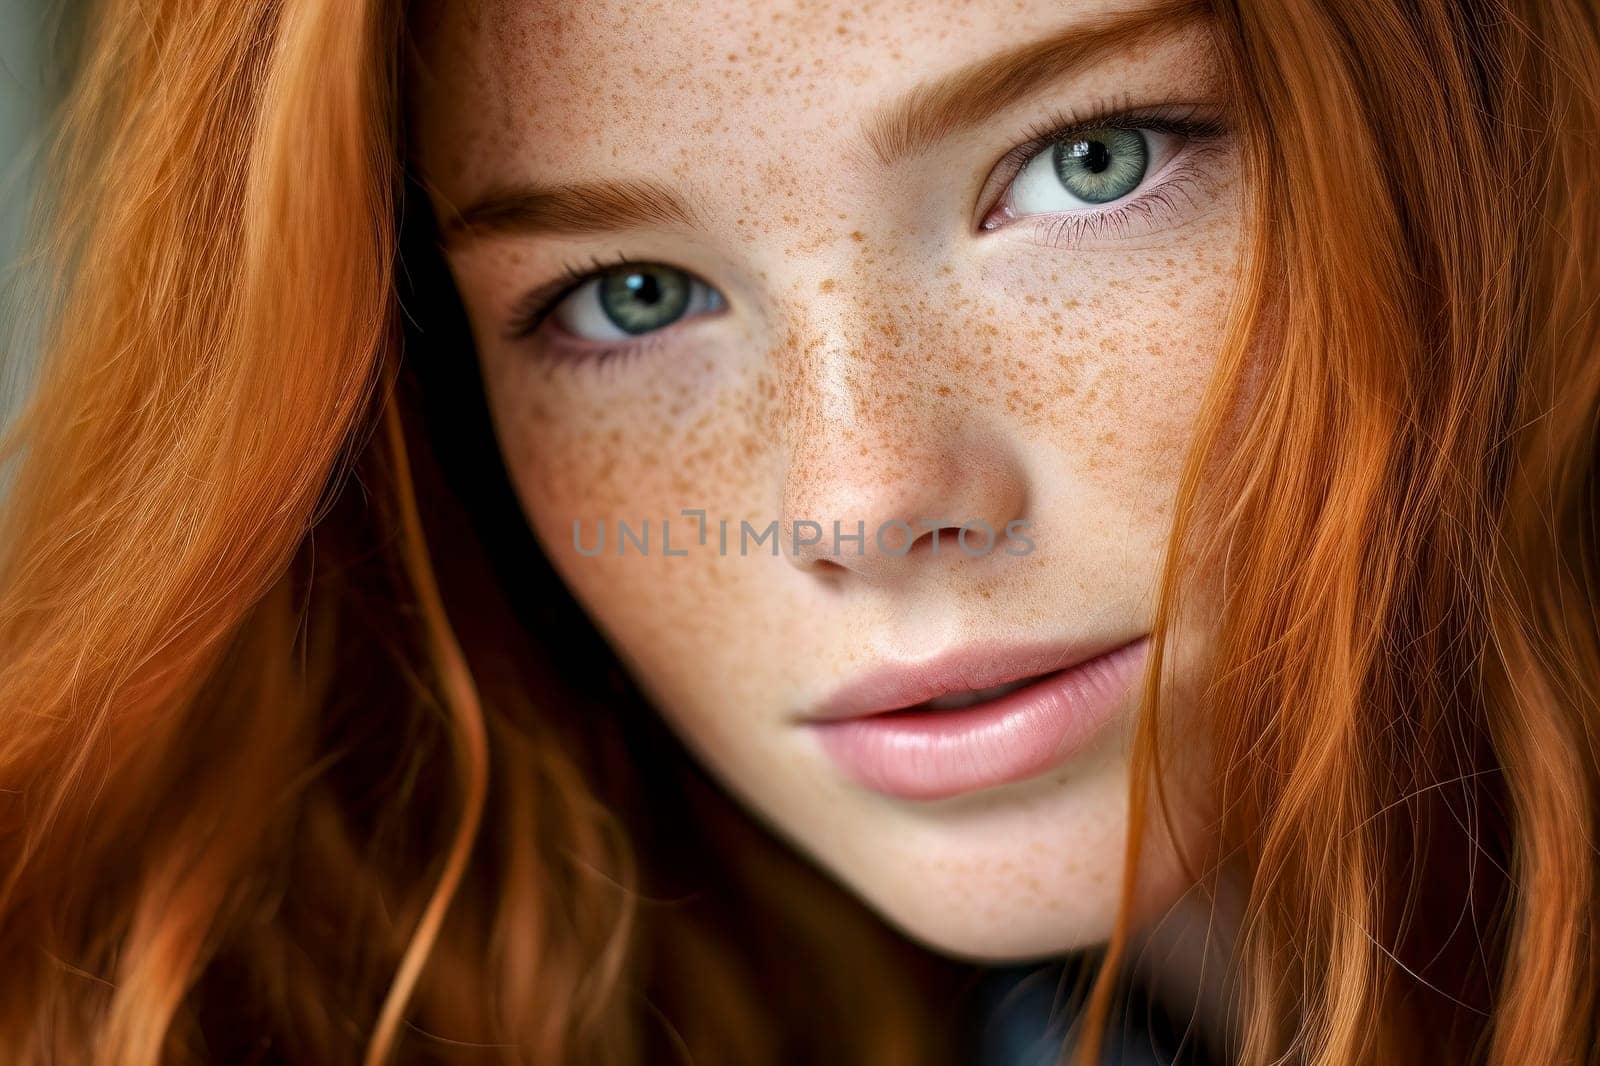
[862, 0, 1208, 166]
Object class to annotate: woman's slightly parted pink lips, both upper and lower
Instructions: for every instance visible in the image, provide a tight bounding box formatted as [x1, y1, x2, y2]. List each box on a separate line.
[806, 637, 1149, 800]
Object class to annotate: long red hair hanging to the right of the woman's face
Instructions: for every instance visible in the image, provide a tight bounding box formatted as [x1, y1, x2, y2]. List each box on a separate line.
[1083, 0, 1600, 1066]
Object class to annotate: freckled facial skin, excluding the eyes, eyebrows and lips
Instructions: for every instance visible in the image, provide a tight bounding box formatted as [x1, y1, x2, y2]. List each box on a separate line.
[410, 0, 1242, 959]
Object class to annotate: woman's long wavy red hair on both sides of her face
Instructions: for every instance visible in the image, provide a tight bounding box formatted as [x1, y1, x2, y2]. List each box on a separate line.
[0, 0, 1600, 1066]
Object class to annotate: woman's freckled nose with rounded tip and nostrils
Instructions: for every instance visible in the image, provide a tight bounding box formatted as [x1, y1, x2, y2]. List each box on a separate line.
[781, 312, 1030, 583]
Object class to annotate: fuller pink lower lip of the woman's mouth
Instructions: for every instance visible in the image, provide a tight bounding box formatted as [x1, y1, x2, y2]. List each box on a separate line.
[808, 637, 1150, 800]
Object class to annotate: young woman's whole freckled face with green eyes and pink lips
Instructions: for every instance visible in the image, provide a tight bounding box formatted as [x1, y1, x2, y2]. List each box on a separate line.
[411, 0, 1242, 959]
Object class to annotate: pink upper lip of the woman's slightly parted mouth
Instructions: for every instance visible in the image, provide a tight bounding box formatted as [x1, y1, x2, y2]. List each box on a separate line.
[806, 637, 1141, 722]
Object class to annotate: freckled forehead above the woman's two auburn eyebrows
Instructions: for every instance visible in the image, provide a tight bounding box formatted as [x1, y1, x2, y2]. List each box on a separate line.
[408, 0, 1196, 192]
